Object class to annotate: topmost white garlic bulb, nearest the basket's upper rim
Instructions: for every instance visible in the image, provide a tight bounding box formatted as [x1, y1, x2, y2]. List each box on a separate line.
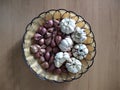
[60, 18, 75, 34]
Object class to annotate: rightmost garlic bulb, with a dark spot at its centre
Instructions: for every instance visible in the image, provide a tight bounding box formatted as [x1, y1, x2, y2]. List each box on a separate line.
[72, 44, 88, 60]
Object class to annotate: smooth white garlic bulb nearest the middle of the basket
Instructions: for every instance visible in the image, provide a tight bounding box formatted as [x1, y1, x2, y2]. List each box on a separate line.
[59, 37, 73, 51]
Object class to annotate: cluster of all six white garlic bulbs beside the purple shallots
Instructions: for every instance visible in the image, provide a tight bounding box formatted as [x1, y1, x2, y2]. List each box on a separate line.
[54, 18, 88, 74]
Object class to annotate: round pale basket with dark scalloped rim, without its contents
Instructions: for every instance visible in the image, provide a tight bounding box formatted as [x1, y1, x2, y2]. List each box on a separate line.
[22, 9, 96, 82]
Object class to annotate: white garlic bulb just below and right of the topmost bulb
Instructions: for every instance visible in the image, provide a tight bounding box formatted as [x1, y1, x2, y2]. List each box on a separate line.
[72, 27, 87, 43]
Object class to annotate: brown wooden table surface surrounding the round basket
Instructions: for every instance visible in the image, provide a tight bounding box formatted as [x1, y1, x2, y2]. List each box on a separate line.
[0, 0, 120, 90]
